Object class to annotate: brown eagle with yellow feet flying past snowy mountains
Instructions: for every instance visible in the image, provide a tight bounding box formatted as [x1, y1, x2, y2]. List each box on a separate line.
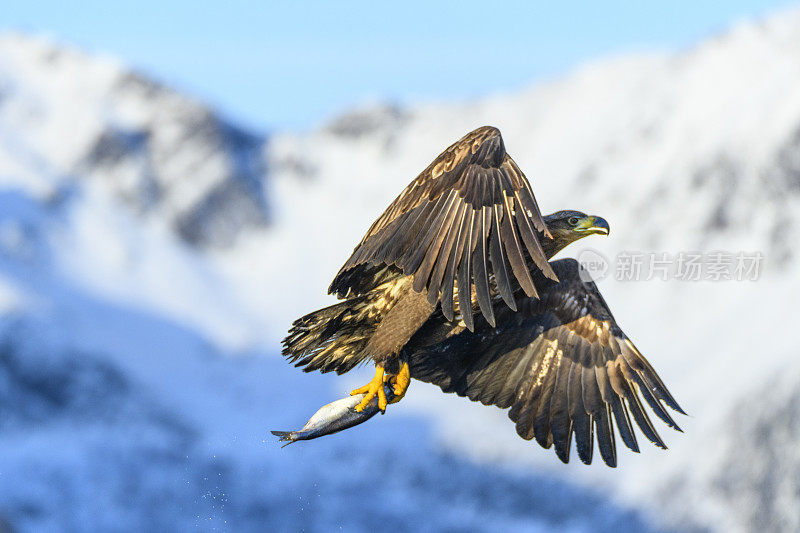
[283, 126, 685, 467]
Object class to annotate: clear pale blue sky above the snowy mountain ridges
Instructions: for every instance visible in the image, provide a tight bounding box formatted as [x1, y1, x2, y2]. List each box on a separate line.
[0, 0, 795, 130]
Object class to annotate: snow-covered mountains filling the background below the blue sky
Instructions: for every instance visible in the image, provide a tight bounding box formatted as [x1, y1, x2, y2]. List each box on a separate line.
[0, 10, 800, 531]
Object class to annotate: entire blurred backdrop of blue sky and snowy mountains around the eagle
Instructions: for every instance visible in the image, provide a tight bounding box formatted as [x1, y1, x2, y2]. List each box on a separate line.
[0, 0, 800, 531]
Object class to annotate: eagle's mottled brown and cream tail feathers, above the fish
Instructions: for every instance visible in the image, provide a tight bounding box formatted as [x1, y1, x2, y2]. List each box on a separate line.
[282, 295, 376, 374]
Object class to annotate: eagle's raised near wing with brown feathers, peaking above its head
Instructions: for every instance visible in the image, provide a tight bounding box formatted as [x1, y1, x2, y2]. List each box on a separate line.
[328, 126, 555, 329]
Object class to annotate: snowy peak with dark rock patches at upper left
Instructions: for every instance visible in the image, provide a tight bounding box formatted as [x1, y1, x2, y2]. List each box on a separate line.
[0, 34, 269, 246]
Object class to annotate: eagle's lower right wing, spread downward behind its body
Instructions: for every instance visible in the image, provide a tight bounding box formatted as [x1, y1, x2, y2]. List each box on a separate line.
[408, 259, 685, 466]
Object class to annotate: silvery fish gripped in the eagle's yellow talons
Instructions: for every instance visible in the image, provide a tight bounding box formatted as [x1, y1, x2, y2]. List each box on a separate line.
[270, 383, 394, 448]
